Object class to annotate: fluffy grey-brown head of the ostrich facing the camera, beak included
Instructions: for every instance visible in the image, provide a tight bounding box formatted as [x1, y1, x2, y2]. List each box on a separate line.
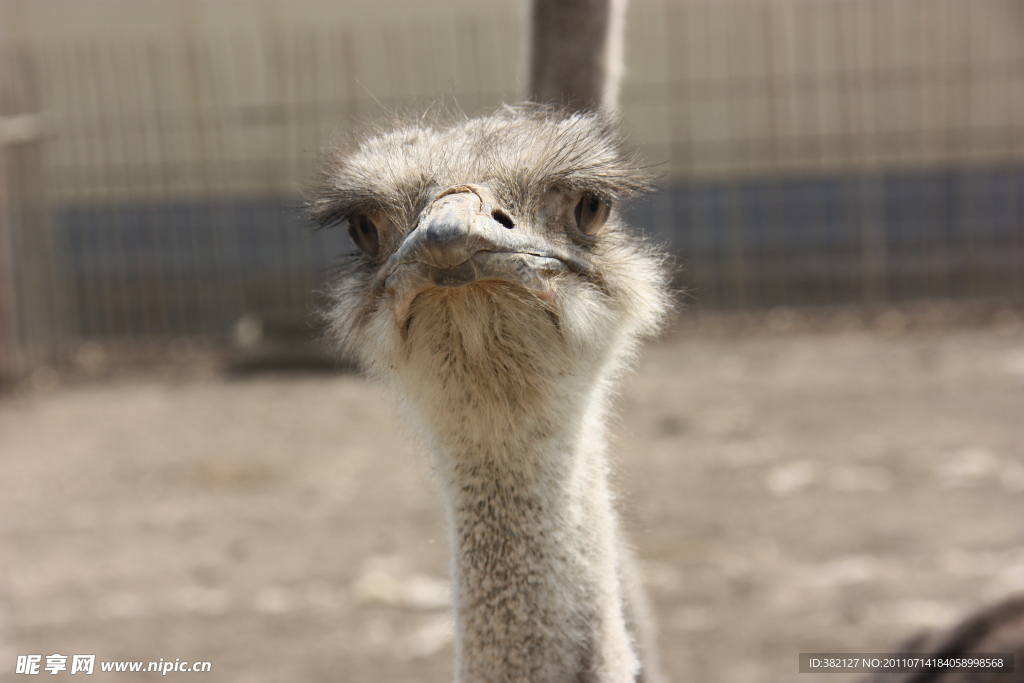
[309, 105, 667, 425]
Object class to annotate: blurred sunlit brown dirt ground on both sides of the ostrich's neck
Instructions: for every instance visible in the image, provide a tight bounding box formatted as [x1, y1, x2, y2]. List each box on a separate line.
[0, 314, 1024, 683]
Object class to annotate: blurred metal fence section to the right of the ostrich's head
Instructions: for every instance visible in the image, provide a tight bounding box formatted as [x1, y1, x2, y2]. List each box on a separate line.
[624, 0, 1024, 307]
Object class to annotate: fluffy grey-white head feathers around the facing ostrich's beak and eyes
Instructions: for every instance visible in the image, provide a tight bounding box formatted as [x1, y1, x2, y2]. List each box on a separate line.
[308, 104, 669, 412]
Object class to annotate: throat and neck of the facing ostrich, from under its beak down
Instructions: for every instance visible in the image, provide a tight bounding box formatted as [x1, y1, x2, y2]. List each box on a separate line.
[393, 283, 639, 683]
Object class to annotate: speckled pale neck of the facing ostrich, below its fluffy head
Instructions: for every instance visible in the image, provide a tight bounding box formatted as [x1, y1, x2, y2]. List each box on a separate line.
[421, 387, 638, 683]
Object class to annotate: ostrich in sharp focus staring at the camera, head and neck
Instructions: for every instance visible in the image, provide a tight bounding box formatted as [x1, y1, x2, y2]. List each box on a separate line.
[309, 104, 670, 683]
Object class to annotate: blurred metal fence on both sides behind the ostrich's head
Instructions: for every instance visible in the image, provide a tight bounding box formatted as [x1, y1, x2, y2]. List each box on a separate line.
[0, 0, 1024, 376]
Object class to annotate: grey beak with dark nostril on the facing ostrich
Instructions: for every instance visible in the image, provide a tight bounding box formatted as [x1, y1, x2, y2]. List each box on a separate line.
[375, 185, 594, 327]
